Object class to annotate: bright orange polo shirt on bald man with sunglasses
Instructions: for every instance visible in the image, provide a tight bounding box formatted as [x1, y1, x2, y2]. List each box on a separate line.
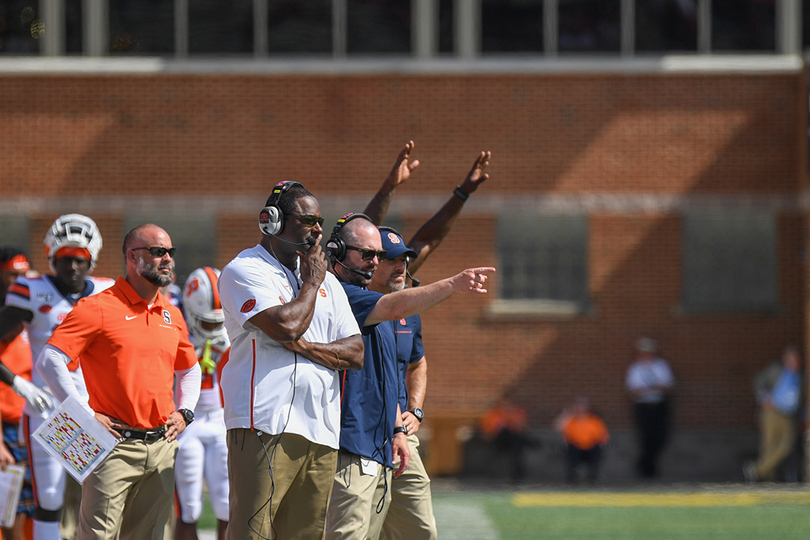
[48, 277, 197, 429]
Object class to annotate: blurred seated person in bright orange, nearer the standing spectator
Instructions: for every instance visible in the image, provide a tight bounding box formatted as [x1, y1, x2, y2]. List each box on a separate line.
[554, 396, 610, 484]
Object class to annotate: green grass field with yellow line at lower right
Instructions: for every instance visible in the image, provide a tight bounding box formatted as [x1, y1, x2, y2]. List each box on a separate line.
[200, 485, 810, 540]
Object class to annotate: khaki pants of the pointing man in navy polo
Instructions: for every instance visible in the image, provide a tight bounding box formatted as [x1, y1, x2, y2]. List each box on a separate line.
[326, 451, 393, 540]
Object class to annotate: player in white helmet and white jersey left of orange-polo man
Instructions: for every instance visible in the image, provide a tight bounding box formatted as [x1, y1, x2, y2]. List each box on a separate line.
[0, 214, 115, 540]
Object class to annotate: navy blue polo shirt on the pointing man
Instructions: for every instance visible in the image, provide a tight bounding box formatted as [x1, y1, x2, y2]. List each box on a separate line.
[340, 282, 404, 467]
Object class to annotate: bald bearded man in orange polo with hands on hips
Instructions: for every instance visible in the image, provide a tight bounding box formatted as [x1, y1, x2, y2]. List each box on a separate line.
[37, 224, 201, 540]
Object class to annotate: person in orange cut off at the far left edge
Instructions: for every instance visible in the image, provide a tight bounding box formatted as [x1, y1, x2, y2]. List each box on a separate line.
[0, 247, 34, 540]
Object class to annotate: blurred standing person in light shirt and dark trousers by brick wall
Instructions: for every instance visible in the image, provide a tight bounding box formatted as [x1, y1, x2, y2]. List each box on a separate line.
[625, 337, 675, 478]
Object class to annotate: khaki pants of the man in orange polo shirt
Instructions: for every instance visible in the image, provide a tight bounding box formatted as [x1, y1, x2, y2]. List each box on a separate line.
[77, 439, 177, 540]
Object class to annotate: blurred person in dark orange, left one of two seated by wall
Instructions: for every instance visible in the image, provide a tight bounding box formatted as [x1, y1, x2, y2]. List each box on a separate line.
[480, 396, 526, 482]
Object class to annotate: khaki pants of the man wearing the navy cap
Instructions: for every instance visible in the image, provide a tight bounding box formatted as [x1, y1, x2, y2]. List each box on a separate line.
[383, 435, 438, 540]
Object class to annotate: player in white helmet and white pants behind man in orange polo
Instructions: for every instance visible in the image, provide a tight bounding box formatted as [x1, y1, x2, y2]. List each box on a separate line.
[175, 266, 231, 540]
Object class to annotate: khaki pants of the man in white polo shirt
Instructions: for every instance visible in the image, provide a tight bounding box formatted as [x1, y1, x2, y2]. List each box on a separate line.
[227, 428, 337, 540]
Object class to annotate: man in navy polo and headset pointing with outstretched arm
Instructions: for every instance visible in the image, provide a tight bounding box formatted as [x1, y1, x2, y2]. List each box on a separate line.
[326, 214, 495, 539]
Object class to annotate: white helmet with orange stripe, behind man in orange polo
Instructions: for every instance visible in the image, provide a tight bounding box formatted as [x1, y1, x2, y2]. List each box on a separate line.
[183, 266, 227, 341]
